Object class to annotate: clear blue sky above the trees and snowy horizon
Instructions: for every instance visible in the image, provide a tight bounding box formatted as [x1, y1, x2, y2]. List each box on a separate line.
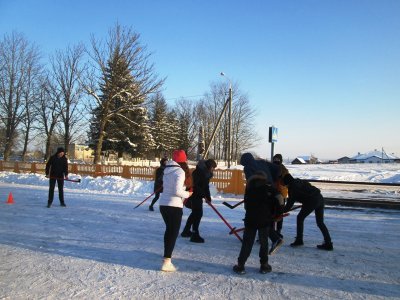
[0, 0, 400, 159]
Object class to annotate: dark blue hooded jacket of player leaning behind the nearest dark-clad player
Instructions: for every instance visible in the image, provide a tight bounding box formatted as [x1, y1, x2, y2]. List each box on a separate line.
[240, 153, 281, 186]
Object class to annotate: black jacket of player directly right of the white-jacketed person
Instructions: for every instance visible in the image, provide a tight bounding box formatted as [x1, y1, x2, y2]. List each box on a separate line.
[189, 160, 213, 201]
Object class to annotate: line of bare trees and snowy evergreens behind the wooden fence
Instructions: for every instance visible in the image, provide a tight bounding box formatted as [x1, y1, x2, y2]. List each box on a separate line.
[0, 24, 257, 163]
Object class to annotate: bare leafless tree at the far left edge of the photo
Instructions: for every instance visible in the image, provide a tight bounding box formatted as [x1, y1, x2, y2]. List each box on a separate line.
[0, 32, 38, 160]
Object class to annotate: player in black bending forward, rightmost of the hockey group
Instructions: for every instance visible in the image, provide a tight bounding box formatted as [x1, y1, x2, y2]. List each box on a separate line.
[283, 174, 333, 250]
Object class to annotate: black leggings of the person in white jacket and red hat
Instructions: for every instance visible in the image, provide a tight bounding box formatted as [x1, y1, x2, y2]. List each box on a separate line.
[160, 205, 183, 258]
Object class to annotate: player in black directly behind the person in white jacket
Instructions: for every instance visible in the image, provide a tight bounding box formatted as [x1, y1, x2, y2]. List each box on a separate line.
[181, 159, 217, 243]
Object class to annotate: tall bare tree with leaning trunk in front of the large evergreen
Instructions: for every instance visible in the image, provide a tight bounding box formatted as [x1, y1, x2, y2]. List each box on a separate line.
[84, 24, 164, 163]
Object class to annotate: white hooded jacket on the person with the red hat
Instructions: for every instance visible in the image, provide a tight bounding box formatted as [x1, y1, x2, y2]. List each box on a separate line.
[159, 160, 189, 208]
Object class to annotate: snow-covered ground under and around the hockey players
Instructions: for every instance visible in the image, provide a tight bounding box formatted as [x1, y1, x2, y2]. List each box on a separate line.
[0, 165, 400, 299]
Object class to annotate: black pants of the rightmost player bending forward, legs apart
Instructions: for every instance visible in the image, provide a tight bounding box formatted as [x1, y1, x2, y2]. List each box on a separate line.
[296, 195, 331, 243]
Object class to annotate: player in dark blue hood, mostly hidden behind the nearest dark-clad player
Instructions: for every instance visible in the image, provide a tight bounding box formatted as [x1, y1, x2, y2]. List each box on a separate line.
[240, 153, 284, 254]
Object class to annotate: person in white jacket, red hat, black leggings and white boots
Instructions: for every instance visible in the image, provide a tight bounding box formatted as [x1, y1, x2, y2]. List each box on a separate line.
[159, 150, 192, 272]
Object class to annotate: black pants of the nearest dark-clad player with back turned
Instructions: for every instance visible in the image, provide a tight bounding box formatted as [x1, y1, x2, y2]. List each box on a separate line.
[238, 227, 270, 265]
